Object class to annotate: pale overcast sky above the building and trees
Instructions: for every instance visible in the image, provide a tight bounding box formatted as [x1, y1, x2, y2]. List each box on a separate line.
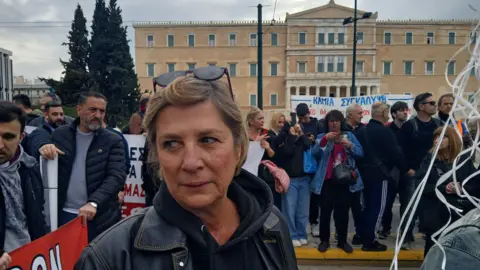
[0, 0, 480, 79]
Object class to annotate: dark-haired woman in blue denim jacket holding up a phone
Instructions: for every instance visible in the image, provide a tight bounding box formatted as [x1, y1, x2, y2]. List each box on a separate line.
[311, 110, 363, 253]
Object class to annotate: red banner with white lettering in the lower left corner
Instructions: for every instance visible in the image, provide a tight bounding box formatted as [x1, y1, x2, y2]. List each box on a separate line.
[8, 217, 88, 270]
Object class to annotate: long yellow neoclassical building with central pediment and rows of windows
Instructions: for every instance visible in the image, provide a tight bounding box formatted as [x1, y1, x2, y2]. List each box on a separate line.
[134, 0, 480, 109]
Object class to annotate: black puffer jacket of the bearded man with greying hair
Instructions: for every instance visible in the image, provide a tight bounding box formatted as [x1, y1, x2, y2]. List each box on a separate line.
[52, 119, 126, 234]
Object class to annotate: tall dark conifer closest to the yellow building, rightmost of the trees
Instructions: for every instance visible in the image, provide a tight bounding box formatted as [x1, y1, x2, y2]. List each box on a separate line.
[104, 0, 140, 124]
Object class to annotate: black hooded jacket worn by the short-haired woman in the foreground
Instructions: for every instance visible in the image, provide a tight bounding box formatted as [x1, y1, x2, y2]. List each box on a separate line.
[74, 170, 298, 270]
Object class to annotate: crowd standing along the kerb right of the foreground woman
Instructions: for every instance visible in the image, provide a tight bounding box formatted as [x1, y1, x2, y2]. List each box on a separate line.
[247, 93, 480, 255]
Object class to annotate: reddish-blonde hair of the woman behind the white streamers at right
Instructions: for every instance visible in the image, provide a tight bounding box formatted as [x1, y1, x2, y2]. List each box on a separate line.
[430, 126, 462, 163]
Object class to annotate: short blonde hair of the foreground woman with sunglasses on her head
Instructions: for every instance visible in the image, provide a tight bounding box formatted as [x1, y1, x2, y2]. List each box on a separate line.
[143, 76, 248, 176]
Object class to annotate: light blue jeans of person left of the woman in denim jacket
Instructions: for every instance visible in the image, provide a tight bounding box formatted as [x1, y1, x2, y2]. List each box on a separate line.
[282, 176, 310, 240]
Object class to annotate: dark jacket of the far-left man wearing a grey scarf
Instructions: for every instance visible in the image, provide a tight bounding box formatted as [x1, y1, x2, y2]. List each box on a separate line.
[0, 150, 49, 251]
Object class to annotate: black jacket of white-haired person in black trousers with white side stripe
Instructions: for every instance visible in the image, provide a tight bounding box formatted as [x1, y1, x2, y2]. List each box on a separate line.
[356, 119, 408, 181]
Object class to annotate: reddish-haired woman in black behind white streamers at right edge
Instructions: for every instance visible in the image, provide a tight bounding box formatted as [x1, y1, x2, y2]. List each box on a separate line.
[414, 126, 478, 256]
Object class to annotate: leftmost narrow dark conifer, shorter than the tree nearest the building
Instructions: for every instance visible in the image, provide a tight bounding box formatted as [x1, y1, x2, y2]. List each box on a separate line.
[61, 4, 90, 105]
